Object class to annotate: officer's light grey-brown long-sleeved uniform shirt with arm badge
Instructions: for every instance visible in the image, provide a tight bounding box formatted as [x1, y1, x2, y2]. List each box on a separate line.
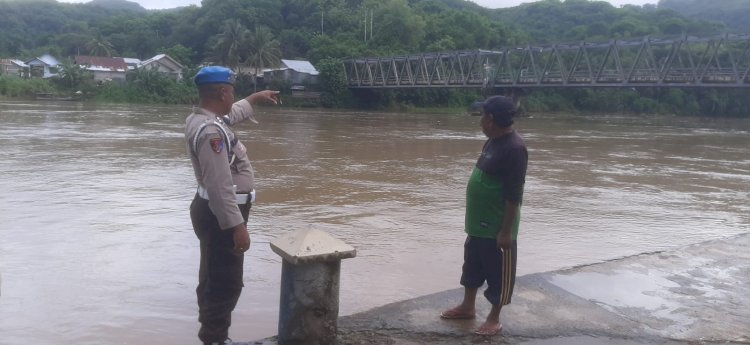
[185, 99, 256, 229]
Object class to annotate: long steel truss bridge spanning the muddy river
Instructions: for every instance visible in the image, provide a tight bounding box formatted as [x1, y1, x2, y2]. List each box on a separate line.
[344, 34, 750, 89]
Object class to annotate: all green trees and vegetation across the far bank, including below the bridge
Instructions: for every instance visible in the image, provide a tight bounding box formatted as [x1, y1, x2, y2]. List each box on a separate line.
[0, 0, 750, 117]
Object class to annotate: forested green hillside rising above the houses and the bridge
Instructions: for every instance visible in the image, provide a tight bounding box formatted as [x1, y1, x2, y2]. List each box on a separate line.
[0, 0, 724, 64]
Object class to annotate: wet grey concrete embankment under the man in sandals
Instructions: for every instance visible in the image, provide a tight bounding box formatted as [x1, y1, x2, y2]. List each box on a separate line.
[251, 234, 750, 345]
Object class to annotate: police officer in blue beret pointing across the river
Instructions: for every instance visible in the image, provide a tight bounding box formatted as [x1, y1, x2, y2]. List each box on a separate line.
[185, 66, 279, 344]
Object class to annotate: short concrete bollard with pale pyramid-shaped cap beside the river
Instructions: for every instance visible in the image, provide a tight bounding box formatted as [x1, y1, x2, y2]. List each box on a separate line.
[271, 229, 357, 345]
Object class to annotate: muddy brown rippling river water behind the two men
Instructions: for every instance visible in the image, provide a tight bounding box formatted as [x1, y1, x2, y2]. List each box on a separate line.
[0, 103, 750, 345]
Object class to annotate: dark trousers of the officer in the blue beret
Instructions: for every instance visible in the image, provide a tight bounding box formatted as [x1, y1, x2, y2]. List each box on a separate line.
[190, 195, 250, 343]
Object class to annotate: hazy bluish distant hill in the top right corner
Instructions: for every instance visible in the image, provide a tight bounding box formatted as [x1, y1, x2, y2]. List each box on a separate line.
[658, 0, 750, 33]
